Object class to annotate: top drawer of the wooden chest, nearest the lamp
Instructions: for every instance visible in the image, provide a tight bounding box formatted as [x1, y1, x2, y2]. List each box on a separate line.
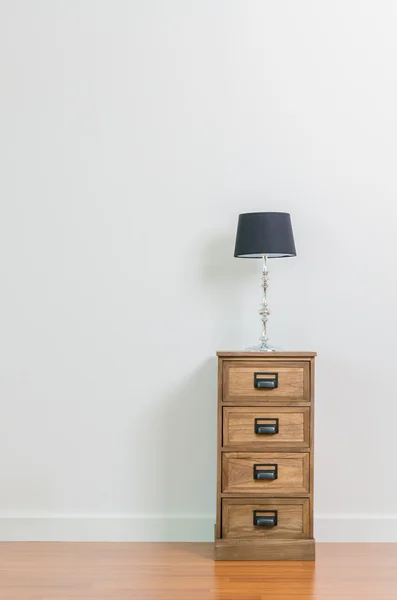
[223, 360, 310, 404]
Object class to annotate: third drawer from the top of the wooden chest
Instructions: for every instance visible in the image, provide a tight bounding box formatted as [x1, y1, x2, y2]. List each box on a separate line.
[222, 452, 309, 496]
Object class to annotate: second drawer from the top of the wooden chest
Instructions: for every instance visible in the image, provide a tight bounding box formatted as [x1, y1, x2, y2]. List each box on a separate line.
[223, 406, 310, 450]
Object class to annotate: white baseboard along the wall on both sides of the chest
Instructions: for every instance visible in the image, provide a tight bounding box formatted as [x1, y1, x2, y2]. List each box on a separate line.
[0, 514, 397, 542]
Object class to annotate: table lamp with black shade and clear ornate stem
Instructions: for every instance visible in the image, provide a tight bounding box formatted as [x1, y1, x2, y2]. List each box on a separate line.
[234, 212, 296, 352]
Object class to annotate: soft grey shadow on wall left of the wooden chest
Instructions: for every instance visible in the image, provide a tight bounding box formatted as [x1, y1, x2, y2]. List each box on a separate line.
[153, 356, 217, 541]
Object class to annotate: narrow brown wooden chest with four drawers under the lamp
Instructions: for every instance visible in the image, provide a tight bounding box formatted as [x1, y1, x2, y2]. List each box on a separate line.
[215, 352, 316, 560]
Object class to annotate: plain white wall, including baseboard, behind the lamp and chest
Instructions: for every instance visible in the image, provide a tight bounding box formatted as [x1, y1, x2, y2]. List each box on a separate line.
[0, 0, 397, 541]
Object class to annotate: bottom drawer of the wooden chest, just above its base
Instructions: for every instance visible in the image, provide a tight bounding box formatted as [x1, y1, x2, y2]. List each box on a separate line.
[222, 498, 309, 540]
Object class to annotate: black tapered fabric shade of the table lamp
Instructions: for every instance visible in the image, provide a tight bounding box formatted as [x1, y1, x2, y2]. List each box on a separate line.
[234, 212, 296, 258]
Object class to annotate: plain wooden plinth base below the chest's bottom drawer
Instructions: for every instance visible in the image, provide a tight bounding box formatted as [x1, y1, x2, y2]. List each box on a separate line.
[214, 539, 315, 560]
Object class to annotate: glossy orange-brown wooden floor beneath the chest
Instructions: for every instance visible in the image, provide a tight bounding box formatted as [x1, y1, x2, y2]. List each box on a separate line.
[0, 543, 397, 600]
